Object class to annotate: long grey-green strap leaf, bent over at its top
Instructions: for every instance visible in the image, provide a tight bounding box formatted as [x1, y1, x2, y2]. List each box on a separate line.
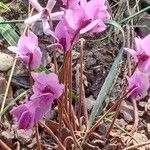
[82, 20, 125, 143]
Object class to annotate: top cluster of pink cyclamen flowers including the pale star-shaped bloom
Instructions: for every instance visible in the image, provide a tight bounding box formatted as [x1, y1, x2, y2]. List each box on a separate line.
[25, 0, 110, 53]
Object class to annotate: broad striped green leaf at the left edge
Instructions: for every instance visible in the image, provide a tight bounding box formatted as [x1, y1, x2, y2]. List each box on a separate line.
[0, 17, 19, 46]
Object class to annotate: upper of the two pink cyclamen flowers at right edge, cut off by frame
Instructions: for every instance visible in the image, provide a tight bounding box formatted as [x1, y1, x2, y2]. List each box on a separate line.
[126, 34, 150, 73]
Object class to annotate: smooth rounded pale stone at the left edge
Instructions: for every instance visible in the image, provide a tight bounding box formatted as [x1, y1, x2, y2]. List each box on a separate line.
[0, 53, 13, 71]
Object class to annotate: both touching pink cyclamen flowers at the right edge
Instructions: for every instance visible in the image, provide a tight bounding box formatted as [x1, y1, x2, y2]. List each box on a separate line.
[126, 34, 150, 100]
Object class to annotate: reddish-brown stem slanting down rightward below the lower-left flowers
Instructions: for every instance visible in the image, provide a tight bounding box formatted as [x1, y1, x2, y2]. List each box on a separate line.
[39, 122, 66, 150]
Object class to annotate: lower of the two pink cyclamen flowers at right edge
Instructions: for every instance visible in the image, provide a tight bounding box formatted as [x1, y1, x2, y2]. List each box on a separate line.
[127, 70, 150, 100]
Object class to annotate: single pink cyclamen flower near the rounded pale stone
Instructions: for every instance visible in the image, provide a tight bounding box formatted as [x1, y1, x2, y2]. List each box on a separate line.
[8, 32, 42, 69]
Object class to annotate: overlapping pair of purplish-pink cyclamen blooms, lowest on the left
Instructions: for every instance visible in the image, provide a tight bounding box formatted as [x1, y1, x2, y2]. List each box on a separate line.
[10, 72, 64, 129]
